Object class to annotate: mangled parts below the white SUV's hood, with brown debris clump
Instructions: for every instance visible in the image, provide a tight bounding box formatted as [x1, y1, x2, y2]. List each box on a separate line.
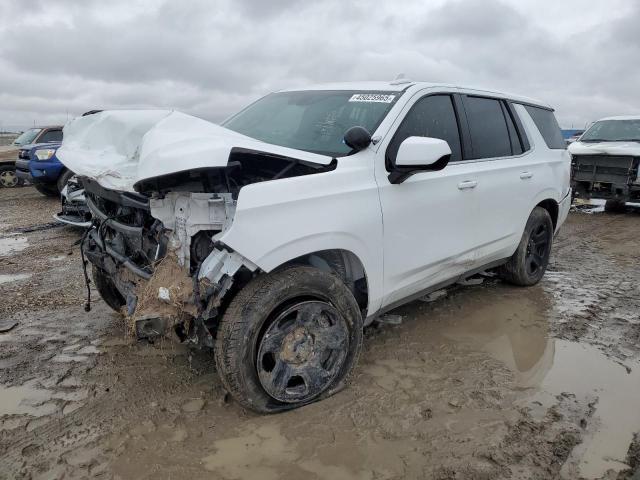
[81, 177, 256, 347]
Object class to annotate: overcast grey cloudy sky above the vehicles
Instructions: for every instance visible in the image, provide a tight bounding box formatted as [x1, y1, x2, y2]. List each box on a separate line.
[0, 0, 640, 129]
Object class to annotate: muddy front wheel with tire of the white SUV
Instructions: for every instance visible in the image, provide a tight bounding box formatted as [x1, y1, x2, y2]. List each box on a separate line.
[214, 266, 363, 413]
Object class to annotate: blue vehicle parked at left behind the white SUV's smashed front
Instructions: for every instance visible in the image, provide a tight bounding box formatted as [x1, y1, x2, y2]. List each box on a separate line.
[16, 141, 73, 197]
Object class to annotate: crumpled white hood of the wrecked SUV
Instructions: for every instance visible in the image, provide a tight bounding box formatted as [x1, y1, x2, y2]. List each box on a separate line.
[57, 110, 332, 192]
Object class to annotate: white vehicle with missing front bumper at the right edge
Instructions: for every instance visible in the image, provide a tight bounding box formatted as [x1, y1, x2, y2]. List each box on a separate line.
[568, 115, 640, 211]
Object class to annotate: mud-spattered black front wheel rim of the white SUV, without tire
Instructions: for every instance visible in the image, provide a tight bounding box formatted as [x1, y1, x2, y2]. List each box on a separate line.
[256, 300, 349, 403]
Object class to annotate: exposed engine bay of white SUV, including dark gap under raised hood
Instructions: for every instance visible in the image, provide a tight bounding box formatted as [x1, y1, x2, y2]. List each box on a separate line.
[80, 148, 335, 347]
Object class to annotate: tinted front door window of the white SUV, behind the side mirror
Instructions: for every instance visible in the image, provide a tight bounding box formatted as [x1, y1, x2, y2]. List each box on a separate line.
[386, 95, 462, 168]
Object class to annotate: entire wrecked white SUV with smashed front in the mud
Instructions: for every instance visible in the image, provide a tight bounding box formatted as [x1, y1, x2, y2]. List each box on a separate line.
[58, 81, 571, 412]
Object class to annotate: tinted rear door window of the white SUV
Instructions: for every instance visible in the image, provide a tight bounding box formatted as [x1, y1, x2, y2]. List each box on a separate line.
[464, 97, 511, 158]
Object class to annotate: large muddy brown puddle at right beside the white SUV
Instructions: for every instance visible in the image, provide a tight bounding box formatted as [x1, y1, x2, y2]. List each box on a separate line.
[439, 288, 640, 479]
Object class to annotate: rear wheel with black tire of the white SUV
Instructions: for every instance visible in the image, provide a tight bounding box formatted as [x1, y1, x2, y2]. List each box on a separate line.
[498, 207, 553, 287]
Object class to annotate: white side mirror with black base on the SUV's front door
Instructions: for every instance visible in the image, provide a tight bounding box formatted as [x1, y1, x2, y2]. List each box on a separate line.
[389, 137, 451, 183]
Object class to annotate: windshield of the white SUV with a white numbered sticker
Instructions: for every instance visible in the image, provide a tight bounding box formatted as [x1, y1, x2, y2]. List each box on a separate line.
[223, 90, 402, 157]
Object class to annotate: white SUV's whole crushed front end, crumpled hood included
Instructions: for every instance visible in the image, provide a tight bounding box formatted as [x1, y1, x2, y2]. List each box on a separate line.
[58, 110, 337, 346]
